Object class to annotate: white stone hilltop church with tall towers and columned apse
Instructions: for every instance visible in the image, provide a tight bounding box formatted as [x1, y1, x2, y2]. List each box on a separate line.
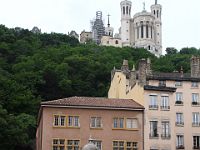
[101, 0, 162, 57]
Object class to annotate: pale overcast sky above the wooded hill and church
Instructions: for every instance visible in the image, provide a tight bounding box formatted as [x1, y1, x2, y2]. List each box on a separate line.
[0, 0, 200, 52]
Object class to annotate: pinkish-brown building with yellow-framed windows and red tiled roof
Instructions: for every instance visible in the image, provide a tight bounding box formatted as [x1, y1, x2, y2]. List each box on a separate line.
[36, 97, 144, 150]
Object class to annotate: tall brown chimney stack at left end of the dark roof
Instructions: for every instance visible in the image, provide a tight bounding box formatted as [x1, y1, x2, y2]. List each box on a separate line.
[138, 59, 147, 86]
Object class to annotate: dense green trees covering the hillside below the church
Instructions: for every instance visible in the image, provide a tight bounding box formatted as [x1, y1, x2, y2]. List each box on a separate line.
[0, 25, 200, 150]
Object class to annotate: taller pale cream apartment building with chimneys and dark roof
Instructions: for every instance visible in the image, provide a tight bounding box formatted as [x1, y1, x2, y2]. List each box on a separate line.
[108, 56, 200, 150]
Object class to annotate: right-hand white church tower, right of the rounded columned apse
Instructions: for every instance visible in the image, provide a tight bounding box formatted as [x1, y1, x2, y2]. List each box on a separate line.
[151, 0, 162, 54]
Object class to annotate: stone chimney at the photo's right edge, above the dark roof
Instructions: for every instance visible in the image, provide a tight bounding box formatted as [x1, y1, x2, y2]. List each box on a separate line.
[190, 56, 200, 78]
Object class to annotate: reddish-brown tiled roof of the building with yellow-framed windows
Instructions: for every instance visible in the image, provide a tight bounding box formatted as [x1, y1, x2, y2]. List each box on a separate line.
[41, 97, 144, 110]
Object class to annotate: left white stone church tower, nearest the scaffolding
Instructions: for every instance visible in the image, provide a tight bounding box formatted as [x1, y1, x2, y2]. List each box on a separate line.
[120, 0, 132, 46]
